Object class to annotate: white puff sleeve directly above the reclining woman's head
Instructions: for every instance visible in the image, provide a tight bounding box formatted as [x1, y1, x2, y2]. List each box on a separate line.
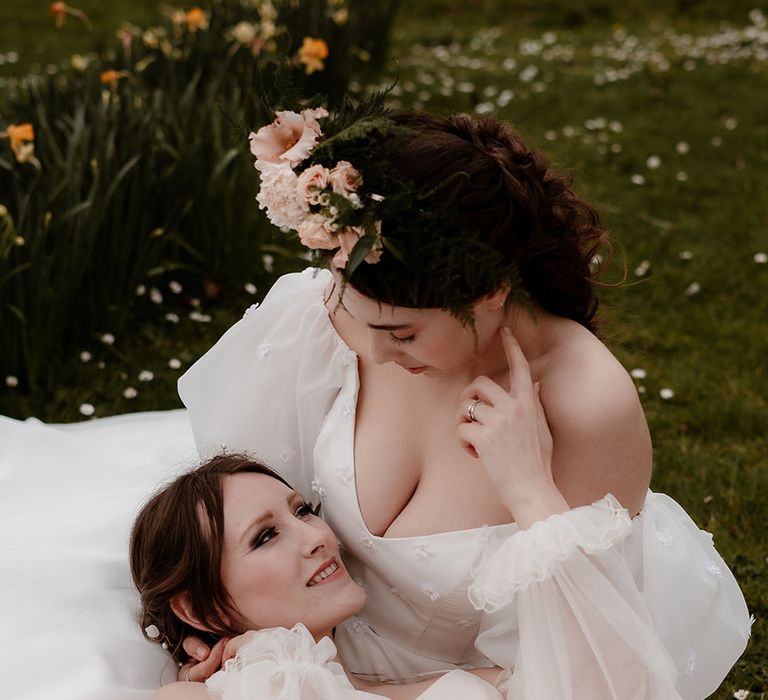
[179, 269, 357, 498]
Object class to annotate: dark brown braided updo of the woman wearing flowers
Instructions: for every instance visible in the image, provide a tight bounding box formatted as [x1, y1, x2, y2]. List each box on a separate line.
[340, 113, 609, 332]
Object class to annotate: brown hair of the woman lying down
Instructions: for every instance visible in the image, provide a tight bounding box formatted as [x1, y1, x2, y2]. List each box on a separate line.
[130, 454, 291, 661]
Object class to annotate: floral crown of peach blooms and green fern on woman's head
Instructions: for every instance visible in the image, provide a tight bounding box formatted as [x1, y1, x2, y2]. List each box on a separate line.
[248, 98, 415, 274]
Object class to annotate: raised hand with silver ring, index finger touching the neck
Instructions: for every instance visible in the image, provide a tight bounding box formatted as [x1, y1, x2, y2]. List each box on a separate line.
[457, 328, 569, 528]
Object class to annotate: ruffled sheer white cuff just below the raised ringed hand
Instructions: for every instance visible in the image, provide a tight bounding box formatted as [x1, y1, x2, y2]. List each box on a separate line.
[469, 494, 632, 612]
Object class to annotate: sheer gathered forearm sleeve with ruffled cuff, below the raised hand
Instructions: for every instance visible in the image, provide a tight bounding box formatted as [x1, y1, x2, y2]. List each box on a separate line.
[469, 496, 680, 700]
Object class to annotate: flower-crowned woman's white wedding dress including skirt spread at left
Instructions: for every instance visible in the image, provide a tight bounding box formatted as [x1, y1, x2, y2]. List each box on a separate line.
[0, 271, 750, 700]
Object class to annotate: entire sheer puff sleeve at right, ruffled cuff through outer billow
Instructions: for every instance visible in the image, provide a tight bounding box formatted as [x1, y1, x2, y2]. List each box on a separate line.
[469, 493, 749, 700]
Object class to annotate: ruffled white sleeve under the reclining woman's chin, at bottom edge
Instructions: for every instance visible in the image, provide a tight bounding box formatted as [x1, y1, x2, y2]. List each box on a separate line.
[206, 623, 382, 700]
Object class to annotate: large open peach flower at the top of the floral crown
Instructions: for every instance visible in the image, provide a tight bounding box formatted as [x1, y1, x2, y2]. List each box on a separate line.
[248, 107, 328, 170]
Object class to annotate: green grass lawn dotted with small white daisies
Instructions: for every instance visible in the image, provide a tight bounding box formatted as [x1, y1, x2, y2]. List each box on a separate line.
[0, 0, 768, 698]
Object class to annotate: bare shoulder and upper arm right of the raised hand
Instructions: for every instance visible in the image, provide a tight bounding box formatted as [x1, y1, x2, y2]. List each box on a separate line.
[538, 329, 652, 514]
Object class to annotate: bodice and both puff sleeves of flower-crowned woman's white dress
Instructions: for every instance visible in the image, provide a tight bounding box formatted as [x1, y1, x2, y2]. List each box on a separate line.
[179, 269, 750, 700]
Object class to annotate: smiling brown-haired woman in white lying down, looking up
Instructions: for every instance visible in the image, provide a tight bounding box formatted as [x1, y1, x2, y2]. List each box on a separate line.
[131, 455, 502, 700]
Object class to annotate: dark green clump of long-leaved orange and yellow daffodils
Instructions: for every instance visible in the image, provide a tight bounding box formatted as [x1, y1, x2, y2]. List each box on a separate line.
[0, 0, 394, 389]
